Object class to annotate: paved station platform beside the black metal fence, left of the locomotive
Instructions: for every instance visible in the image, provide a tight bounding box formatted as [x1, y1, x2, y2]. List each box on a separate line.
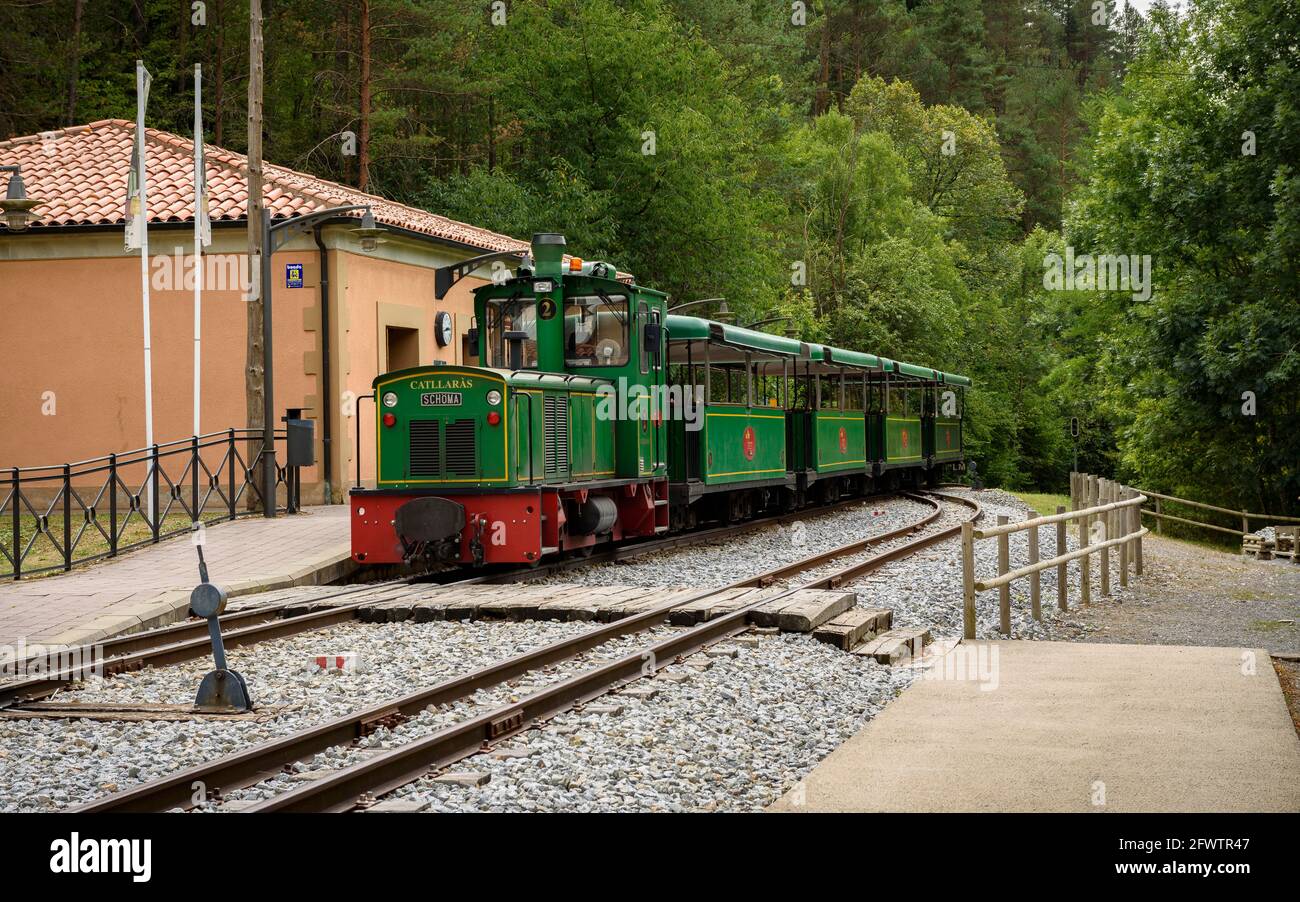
[0, 504, 351, 646]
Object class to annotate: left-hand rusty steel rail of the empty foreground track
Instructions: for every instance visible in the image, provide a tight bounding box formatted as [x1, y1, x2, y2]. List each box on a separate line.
[73, 499, 939, 812]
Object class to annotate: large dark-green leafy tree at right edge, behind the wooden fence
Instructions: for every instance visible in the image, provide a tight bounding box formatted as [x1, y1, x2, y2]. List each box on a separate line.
[1067, 0, 1300, 511]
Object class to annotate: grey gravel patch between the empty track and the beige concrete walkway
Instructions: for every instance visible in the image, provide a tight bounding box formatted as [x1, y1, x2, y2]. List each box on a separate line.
[393, 634, 915, 812]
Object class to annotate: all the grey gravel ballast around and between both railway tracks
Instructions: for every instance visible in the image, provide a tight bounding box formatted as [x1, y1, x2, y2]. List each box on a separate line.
[0, 491, 1086, 811]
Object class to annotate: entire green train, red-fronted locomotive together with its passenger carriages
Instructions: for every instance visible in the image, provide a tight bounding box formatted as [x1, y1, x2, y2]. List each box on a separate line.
[351, 234, 970, 565]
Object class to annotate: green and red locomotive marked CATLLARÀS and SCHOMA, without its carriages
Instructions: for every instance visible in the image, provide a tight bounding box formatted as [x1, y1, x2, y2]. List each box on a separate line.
[351, 234, 668, 565]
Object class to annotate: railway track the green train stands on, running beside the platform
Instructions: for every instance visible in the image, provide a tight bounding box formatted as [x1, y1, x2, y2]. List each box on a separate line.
[0, 499, 878, 710]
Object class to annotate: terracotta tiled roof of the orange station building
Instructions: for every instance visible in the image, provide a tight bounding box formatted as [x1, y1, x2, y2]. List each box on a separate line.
[0, 120, 528, 251]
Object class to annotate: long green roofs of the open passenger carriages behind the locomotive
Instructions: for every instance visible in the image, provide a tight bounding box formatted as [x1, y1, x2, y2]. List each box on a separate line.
[667, 313, 971, 386]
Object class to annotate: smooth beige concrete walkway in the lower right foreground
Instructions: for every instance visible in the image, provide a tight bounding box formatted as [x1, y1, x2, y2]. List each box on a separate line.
[771, 641, 1300, 811]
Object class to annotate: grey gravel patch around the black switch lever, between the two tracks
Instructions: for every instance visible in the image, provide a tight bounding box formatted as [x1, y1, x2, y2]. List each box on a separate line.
[0, 621, 590, 811]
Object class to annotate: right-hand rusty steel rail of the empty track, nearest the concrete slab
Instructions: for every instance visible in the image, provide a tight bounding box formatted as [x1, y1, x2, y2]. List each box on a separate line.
[242, 495, 980, 814]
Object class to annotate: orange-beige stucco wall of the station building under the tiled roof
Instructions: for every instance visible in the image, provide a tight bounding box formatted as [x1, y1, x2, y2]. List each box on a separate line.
[0, 226, 481, 509]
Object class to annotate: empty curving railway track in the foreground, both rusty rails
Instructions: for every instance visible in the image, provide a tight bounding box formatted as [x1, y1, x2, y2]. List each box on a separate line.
[74, 493, 980, 812]
